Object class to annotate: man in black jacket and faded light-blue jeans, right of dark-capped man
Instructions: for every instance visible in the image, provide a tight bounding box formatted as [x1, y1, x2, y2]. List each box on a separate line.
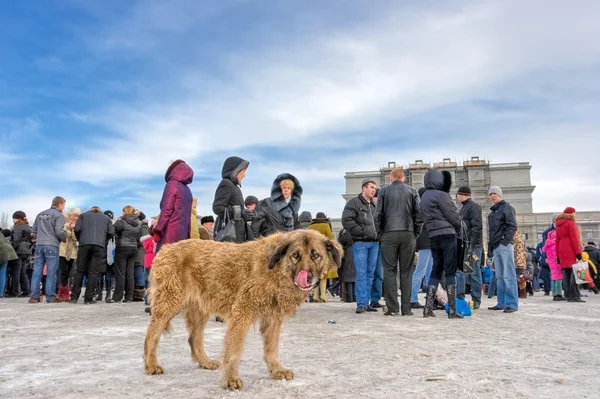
[488, 186, 519, 313]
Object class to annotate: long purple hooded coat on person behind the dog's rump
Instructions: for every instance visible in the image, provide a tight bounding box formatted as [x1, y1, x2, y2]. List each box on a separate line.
[153, 160, 194, 252]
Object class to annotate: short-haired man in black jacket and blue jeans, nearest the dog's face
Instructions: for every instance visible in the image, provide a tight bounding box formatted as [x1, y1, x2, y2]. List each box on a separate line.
[342, 178, 379, 314]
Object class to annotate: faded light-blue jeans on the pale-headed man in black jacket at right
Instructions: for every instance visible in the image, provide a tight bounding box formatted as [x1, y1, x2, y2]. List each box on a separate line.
[494, 244, 519, 310]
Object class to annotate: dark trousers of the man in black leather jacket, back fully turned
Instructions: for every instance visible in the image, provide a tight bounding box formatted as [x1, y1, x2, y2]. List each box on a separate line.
[379, 231, 416, 313]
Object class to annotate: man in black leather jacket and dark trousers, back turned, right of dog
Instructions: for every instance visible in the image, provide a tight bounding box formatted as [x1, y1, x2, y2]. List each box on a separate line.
[377, 168, 422, 316]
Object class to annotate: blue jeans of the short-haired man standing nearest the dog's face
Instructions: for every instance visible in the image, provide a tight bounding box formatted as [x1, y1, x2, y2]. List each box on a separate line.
[352, 242, 379, 307]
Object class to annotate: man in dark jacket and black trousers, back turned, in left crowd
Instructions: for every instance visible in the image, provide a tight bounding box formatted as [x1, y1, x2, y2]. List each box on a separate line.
[69, 206, 115, 304]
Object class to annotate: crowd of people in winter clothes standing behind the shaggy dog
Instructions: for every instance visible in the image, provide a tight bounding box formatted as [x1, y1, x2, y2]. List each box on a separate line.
[0, 157, 600, 319]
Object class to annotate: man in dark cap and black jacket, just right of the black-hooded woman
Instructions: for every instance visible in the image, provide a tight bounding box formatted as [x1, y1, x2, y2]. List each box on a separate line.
[456, 186, 483, 309]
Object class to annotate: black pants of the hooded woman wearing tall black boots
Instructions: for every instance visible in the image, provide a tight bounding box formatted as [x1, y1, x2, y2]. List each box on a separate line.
[429, 234, 457, 287]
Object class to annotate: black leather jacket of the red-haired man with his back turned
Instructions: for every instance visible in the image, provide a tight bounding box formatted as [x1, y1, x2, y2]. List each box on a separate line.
[377, 180, 423, 236]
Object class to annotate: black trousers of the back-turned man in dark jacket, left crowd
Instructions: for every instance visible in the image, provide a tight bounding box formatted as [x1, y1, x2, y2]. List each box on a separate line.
[71, 245, 106, 302]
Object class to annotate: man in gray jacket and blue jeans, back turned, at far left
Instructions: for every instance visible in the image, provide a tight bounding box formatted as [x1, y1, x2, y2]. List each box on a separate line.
[29, 197, 67, 303]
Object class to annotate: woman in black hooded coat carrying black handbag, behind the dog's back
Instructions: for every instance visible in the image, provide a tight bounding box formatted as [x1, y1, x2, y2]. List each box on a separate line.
[213, 157, 254, 242]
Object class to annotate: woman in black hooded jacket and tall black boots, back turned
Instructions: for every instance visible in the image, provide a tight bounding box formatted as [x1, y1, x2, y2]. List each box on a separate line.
[421, 170, 462, 319]
